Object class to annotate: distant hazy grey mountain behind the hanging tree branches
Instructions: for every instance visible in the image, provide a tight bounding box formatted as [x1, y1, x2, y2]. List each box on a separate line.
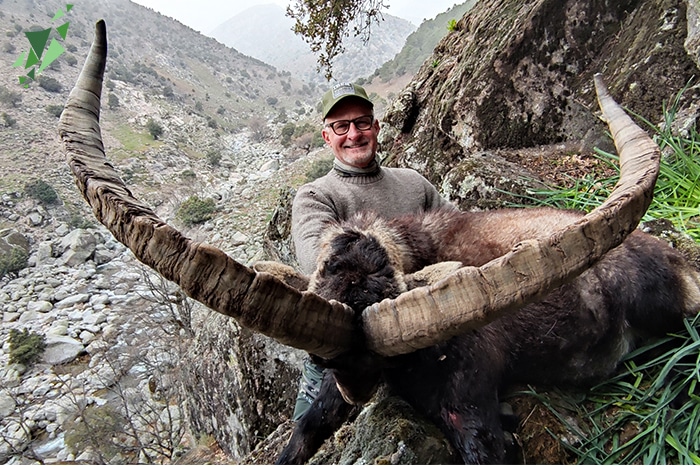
[211, 4, 416, 83]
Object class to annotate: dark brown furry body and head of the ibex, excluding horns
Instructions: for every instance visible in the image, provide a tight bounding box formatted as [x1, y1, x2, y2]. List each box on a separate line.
[279, 208, 700, 464]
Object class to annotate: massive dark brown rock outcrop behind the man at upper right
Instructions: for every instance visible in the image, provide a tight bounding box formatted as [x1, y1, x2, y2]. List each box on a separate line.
[382, 0, 697, 208]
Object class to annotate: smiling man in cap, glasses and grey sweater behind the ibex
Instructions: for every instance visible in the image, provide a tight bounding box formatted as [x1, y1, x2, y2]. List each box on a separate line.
[292, 83, 454, 420]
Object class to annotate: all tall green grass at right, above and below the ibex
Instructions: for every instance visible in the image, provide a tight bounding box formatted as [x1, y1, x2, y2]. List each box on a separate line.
[512, 89, 700, 464]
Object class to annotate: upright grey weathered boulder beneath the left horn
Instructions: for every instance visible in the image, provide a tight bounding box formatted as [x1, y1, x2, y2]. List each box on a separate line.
[183, 312, 304, 461]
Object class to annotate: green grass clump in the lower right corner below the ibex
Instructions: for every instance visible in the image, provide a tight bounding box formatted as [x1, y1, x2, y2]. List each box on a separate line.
[525, 317, 700, 464]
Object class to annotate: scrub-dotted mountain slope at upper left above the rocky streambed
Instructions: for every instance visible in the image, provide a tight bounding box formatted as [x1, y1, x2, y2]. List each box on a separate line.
[0, 0, 322, 213]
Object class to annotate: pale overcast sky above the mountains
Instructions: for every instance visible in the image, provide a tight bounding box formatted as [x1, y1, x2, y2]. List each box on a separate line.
[132, 0, 464, 34]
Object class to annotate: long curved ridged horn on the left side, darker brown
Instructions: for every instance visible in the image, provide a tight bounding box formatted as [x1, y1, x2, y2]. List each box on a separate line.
[58, 21, 354, 358]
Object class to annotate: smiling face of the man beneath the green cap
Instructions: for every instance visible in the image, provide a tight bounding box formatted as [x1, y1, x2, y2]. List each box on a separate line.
[322, 98, 379, 168]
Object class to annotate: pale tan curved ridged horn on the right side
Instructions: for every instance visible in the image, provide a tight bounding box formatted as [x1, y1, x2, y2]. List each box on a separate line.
[363, 75, 660, 356]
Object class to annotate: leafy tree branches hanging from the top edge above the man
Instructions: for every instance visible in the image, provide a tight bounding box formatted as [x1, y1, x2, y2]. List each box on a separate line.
[287, 0, 388, 81]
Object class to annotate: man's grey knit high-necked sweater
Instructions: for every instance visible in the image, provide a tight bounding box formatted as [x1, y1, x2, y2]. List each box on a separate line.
[292, 167, 452, 274]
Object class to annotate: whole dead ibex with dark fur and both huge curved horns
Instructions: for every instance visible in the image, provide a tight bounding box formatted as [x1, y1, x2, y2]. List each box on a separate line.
[59, 21, 700, 462]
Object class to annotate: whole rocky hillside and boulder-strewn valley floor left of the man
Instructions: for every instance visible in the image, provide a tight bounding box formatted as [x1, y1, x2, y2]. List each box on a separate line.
[0, 0, 330, 463]
